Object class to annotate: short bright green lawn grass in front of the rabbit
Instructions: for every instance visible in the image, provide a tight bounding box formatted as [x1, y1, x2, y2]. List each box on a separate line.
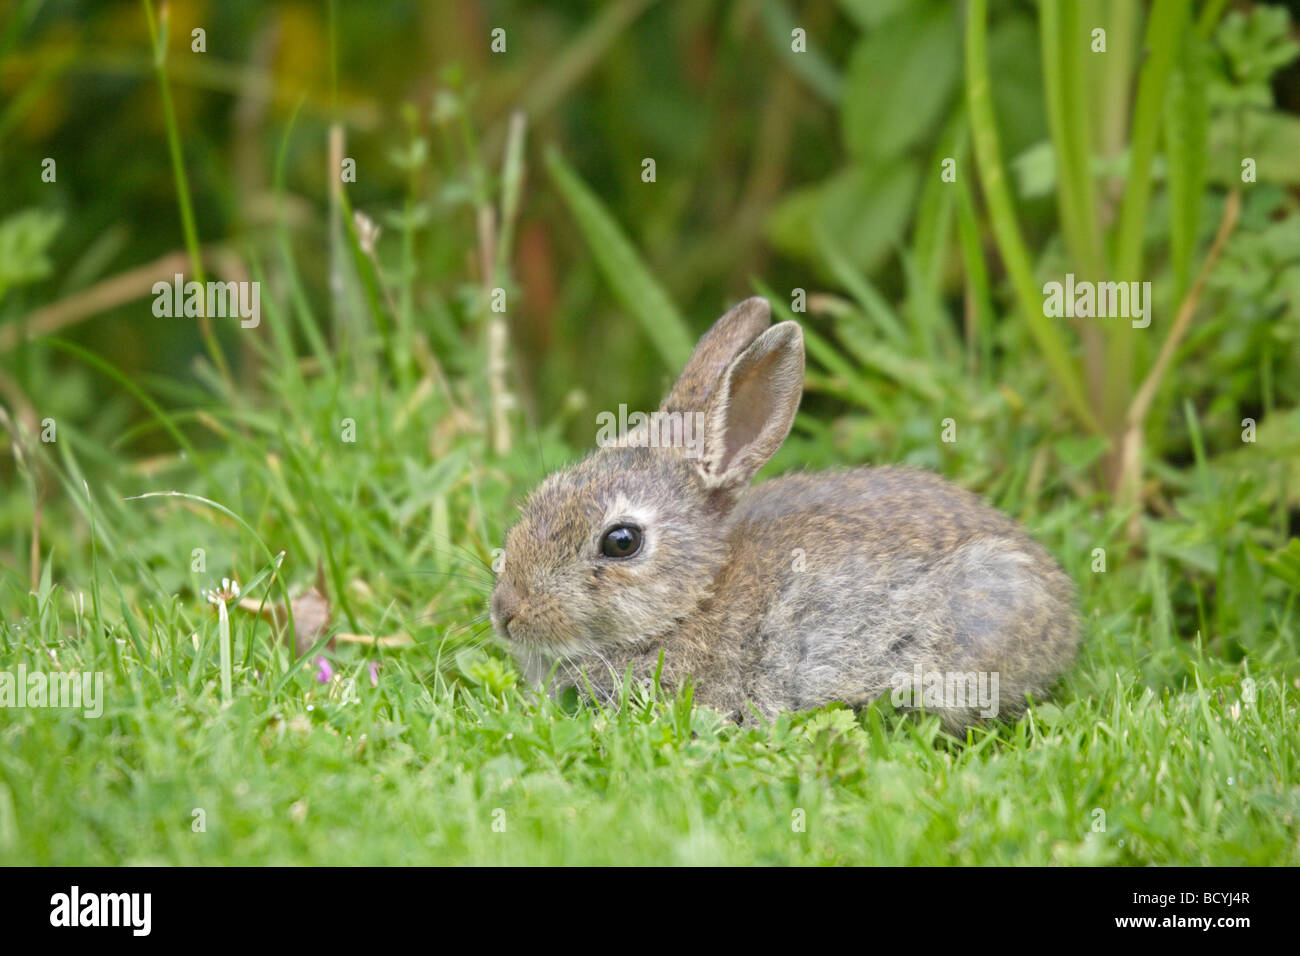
[0, 574, 1300, 864]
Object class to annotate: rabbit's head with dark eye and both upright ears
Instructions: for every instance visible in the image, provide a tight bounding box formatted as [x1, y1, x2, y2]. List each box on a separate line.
[491, 298, 803, 657]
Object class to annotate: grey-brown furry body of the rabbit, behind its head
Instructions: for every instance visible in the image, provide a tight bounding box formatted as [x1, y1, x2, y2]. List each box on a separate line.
[727, 467, 1078, 726]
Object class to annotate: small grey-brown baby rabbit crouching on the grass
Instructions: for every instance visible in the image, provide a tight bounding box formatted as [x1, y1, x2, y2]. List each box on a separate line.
[491, 298, 1079, 730]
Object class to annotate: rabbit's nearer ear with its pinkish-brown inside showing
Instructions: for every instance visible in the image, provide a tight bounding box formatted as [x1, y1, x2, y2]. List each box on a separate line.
[696, 323, 803, 488]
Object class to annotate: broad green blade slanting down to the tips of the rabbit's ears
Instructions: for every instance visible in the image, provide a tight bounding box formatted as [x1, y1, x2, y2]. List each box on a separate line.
[546, 147, 694, 371]
